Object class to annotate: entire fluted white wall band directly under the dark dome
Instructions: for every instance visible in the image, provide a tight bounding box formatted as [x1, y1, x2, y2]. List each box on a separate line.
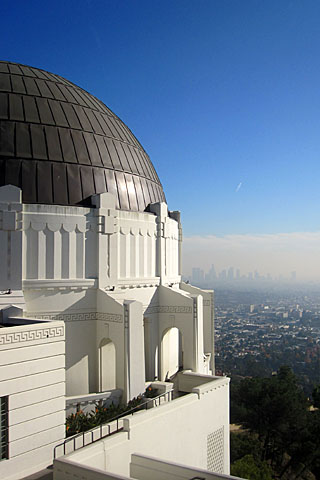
[22, 204, 180, 290]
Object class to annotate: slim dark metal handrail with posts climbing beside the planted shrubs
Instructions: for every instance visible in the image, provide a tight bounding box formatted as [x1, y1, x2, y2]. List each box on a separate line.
[53, 389, 173, 460]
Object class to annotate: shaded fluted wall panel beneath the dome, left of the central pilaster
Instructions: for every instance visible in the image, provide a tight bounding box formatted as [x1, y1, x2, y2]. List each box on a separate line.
[23, 205, 97, 285]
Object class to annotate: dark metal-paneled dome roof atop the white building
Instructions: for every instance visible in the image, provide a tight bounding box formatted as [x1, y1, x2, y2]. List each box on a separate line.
[0, 62, 166, 211]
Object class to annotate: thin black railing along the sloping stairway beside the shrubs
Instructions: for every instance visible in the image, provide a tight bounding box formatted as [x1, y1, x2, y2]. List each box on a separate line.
[53, 390, 173, 459]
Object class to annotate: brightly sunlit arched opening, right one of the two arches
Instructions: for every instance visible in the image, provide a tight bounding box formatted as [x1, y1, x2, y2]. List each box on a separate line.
[161, 327, 183, 381]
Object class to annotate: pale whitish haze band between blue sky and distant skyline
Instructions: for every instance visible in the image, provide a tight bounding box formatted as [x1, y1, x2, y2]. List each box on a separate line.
[182, 231, 320, 282]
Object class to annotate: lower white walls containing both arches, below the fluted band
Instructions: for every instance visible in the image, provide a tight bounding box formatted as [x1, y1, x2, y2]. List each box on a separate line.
[25, 285, 206, 401]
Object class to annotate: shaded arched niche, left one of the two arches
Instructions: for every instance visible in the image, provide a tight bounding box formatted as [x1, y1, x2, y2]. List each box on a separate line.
[99, 338, 116, 392]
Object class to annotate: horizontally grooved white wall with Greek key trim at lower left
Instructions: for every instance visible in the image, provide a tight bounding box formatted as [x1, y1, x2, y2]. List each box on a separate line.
[0, 322, 65, 480]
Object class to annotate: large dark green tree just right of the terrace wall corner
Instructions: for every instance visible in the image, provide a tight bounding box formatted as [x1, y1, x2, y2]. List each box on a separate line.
[233, 366, 308, 474]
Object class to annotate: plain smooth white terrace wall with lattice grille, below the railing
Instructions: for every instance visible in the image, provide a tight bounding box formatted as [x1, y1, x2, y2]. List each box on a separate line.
[62, 378, 229, 475]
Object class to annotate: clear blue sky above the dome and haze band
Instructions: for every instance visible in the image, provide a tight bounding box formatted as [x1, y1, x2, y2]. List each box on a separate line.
[0, 0, 320, 278]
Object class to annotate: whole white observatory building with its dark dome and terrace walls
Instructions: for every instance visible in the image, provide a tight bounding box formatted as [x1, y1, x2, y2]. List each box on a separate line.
[0, 62, 229, 480]
